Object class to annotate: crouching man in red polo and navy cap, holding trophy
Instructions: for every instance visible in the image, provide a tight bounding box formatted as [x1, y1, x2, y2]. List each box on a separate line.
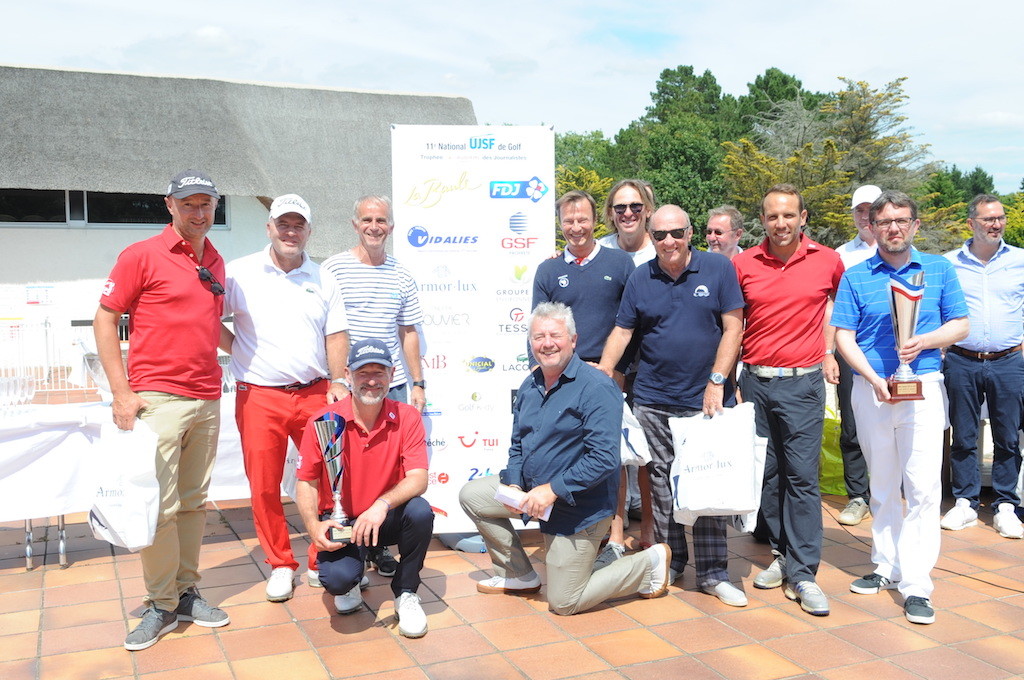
[296, 338, 434, 638]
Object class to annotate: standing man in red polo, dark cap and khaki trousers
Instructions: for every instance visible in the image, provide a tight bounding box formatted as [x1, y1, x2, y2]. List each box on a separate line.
[93, 170, 228, 651]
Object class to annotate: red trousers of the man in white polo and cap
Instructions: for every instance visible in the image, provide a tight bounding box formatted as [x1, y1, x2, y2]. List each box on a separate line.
[234, 380, 331, 569]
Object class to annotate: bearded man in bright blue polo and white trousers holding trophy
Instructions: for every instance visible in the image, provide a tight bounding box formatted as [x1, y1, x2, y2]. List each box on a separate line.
[831, 192, 968, 624]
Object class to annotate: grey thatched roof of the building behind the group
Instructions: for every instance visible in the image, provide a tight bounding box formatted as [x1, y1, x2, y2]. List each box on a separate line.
[0, 67, 476, 252]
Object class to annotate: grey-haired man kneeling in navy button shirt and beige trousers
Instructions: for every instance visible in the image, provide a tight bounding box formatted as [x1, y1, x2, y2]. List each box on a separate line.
[459, 302, 672, 615]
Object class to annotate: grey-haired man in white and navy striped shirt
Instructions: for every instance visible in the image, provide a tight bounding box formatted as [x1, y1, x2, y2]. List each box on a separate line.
[321, 196, 427, 413]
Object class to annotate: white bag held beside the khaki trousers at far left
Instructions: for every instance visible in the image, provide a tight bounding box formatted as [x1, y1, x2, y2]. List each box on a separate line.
[89, 420, 160, 552]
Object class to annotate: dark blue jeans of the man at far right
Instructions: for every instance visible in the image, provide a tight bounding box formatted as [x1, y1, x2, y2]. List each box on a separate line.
[942, 351, 1024, 509]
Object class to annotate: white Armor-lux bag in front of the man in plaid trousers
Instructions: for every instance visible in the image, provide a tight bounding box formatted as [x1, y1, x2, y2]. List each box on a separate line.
[669, 402, 765, 524]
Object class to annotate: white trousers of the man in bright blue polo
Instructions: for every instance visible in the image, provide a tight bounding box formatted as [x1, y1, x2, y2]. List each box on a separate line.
[851, 372, 948, 599]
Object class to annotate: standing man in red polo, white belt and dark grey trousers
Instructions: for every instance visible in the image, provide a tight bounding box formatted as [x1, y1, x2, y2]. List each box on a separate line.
[732, 184, 843, 617]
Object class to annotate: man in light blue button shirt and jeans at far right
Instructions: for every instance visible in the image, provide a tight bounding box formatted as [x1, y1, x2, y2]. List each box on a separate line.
[942, 194, 1024, 539]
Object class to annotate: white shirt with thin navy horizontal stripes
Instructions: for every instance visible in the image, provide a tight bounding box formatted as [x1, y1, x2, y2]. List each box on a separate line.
[321, 251, 423, 387]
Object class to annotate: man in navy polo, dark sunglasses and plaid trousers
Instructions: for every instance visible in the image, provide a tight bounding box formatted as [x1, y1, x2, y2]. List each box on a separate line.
[598, 206, 746, 606]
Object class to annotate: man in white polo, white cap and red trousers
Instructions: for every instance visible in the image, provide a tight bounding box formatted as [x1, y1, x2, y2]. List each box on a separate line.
[221, 194, 348, 602]
